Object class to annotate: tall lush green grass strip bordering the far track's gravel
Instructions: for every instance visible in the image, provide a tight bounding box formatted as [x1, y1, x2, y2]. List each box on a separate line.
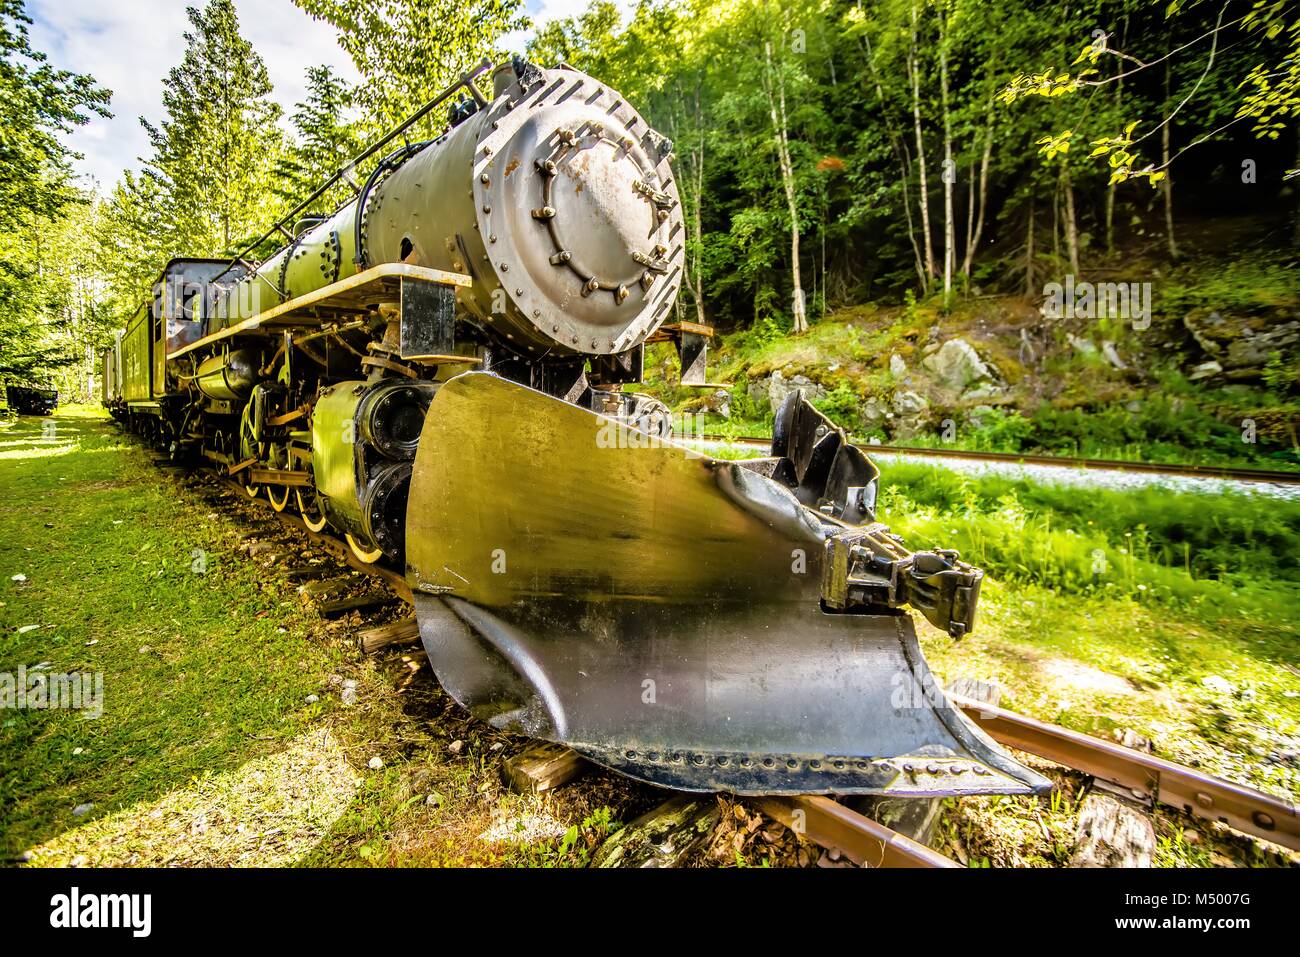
[880, 463, 1300, 620]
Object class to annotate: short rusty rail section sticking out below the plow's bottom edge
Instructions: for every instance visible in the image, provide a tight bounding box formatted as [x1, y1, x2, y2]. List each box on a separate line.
[755, 794, 961, 867]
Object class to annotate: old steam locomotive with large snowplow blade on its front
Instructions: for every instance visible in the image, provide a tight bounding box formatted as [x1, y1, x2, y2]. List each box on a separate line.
[104, 60, 1047, 794]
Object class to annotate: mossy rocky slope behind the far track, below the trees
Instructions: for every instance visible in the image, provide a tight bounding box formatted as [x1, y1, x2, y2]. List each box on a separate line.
[647, 252, 1300, 467]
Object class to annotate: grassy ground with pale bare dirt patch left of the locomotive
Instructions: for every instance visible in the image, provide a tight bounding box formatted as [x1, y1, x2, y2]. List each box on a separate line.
[0, 408, 646, 866]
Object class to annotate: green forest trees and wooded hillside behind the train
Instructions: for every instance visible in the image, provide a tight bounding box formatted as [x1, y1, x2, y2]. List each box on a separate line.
[0, 0, 1300, 459]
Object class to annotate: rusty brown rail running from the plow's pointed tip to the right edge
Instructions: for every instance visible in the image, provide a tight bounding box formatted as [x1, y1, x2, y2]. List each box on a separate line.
[949, 694, 1300, 850]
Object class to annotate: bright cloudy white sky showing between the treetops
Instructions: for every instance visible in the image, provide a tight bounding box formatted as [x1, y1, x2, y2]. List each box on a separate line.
[27, 0, 632, 191]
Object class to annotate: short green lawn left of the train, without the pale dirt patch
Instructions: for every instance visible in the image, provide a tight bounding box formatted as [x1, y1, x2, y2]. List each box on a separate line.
[0, 410, 351, 853]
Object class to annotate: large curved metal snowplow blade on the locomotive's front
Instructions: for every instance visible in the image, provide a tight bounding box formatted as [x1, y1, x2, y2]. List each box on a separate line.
[406, 372, 1049, 796]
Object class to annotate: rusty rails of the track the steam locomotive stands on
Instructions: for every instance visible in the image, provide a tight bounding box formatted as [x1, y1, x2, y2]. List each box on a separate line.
[192, 462, 1300, 867]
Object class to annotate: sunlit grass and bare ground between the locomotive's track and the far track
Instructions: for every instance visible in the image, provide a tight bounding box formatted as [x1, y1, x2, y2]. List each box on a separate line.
[880, 463, 1300, 796]
